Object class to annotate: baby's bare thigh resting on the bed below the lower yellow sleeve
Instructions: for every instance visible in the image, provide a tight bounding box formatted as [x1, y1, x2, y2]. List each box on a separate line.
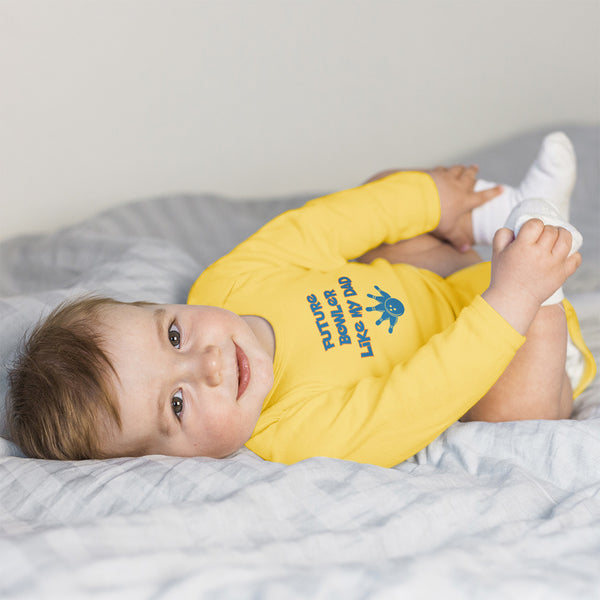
[461, 304, 573, 422]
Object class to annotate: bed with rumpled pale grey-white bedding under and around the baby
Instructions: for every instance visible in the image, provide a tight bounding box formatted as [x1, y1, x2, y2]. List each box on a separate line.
[0, 126, 600, 600]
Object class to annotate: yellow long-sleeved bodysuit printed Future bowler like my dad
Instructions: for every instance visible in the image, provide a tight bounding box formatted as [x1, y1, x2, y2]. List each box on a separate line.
[188, 172, 596, 466]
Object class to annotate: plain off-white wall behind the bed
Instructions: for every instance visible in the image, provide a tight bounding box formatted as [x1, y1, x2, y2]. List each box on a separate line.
[0, 0, 600, 238]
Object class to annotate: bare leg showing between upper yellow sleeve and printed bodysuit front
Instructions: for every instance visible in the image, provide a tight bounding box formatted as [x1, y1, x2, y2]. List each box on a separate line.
[357, 233, 481, 277]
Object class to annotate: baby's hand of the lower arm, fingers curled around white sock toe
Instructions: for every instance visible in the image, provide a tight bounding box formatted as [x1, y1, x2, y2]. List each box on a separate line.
[483, 219, 581, 334]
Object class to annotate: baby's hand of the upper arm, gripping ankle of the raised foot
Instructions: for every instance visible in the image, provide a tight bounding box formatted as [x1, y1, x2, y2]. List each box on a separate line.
[427, 165, 502, 251]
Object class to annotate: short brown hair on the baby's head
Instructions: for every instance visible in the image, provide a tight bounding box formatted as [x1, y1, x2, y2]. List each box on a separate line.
[7, 297, 129, 460]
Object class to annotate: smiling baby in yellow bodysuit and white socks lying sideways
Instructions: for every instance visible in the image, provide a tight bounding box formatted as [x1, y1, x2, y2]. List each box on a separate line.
[9, 133, 595, 466]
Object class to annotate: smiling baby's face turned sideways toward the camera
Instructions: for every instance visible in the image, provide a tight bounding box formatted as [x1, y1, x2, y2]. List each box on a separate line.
[102, 304, 274, 458]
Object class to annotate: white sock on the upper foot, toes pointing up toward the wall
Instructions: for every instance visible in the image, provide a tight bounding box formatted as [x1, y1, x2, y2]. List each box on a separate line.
[473, 131, 577, 245]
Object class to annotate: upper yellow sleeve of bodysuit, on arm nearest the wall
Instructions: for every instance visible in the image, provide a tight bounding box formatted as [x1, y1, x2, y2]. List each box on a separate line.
[197, 172, 440, 272]
